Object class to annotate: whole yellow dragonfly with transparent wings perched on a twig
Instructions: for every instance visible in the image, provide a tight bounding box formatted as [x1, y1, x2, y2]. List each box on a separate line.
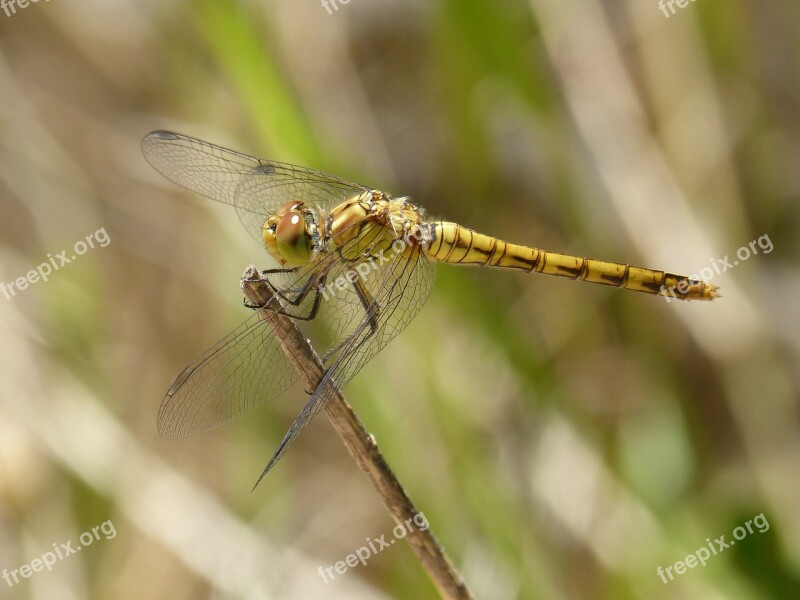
[142, 131, 719, 485]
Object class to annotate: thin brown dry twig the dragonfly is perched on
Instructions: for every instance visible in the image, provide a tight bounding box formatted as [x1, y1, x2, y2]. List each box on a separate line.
[242, 265, 474, 600]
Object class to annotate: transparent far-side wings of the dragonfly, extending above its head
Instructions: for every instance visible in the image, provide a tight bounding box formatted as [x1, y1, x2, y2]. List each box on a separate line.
[142, 131, 369, 243]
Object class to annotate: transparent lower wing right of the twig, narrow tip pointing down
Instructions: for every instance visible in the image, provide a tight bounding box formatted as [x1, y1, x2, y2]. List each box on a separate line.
[253, 236, 436, 481]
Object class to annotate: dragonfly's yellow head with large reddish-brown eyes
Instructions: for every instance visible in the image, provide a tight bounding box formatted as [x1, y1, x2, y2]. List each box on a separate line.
[261, 201, 315, 267]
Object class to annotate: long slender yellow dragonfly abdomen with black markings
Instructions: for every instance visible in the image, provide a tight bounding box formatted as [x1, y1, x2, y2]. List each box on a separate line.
[424, 221, 717, 300]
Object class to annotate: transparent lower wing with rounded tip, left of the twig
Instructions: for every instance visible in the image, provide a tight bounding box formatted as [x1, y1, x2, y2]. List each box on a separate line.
[158, 313, 298, 438]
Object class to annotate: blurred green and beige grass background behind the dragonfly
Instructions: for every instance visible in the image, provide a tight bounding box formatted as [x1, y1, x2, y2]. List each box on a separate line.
[0, 0, 800, 600]
